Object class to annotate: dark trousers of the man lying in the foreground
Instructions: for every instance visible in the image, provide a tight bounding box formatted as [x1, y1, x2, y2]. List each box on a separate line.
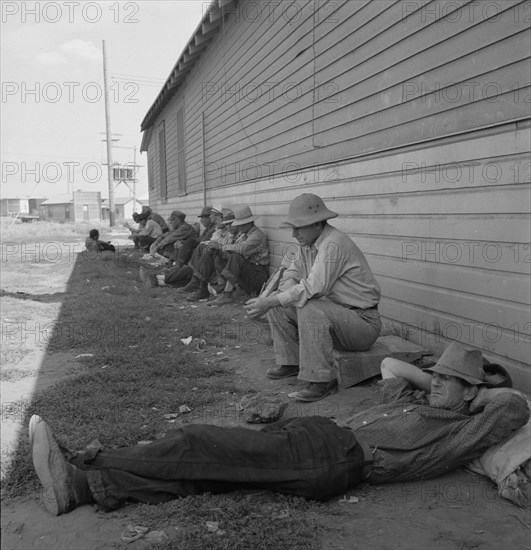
[79, 416, 364, 510]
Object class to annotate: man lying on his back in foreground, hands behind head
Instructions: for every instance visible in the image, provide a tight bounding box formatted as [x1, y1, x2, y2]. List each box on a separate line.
[29, 343, 529, 515]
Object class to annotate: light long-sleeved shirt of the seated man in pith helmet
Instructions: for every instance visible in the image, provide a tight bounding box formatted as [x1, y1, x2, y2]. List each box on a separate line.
[277, 224, 381, 309]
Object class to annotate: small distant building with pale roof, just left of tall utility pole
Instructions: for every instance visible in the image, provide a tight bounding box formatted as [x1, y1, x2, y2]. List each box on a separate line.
[40, 190, 102, 222]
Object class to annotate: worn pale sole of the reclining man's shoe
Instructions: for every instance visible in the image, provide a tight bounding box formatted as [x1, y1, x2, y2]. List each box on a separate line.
[30, 415, 68, 516]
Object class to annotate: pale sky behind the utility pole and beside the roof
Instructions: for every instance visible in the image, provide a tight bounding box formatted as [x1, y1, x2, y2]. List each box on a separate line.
[0, 0, 210, 203]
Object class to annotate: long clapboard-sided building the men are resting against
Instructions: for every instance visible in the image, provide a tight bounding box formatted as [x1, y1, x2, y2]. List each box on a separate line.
[142, 0, 531, 389]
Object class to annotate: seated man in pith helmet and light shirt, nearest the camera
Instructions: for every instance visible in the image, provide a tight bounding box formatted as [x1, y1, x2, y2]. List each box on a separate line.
[246, 193, 382, 401]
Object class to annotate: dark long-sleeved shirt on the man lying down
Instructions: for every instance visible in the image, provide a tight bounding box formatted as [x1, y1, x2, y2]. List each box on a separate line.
[346, 378, 529, 483]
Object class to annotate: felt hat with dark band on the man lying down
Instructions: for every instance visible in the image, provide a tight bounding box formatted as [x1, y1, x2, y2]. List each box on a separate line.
[425, 342, 485, 386]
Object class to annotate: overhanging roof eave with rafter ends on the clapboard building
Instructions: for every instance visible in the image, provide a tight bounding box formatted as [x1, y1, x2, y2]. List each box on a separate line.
[140, 0, 238, 132]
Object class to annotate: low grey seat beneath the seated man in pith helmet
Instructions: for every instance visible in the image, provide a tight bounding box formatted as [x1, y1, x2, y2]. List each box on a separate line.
[334, 336, 432, 388]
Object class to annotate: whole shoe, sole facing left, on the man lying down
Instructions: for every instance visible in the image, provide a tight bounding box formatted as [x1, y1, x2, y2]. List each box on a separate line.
[29, 414, 93, 516]
